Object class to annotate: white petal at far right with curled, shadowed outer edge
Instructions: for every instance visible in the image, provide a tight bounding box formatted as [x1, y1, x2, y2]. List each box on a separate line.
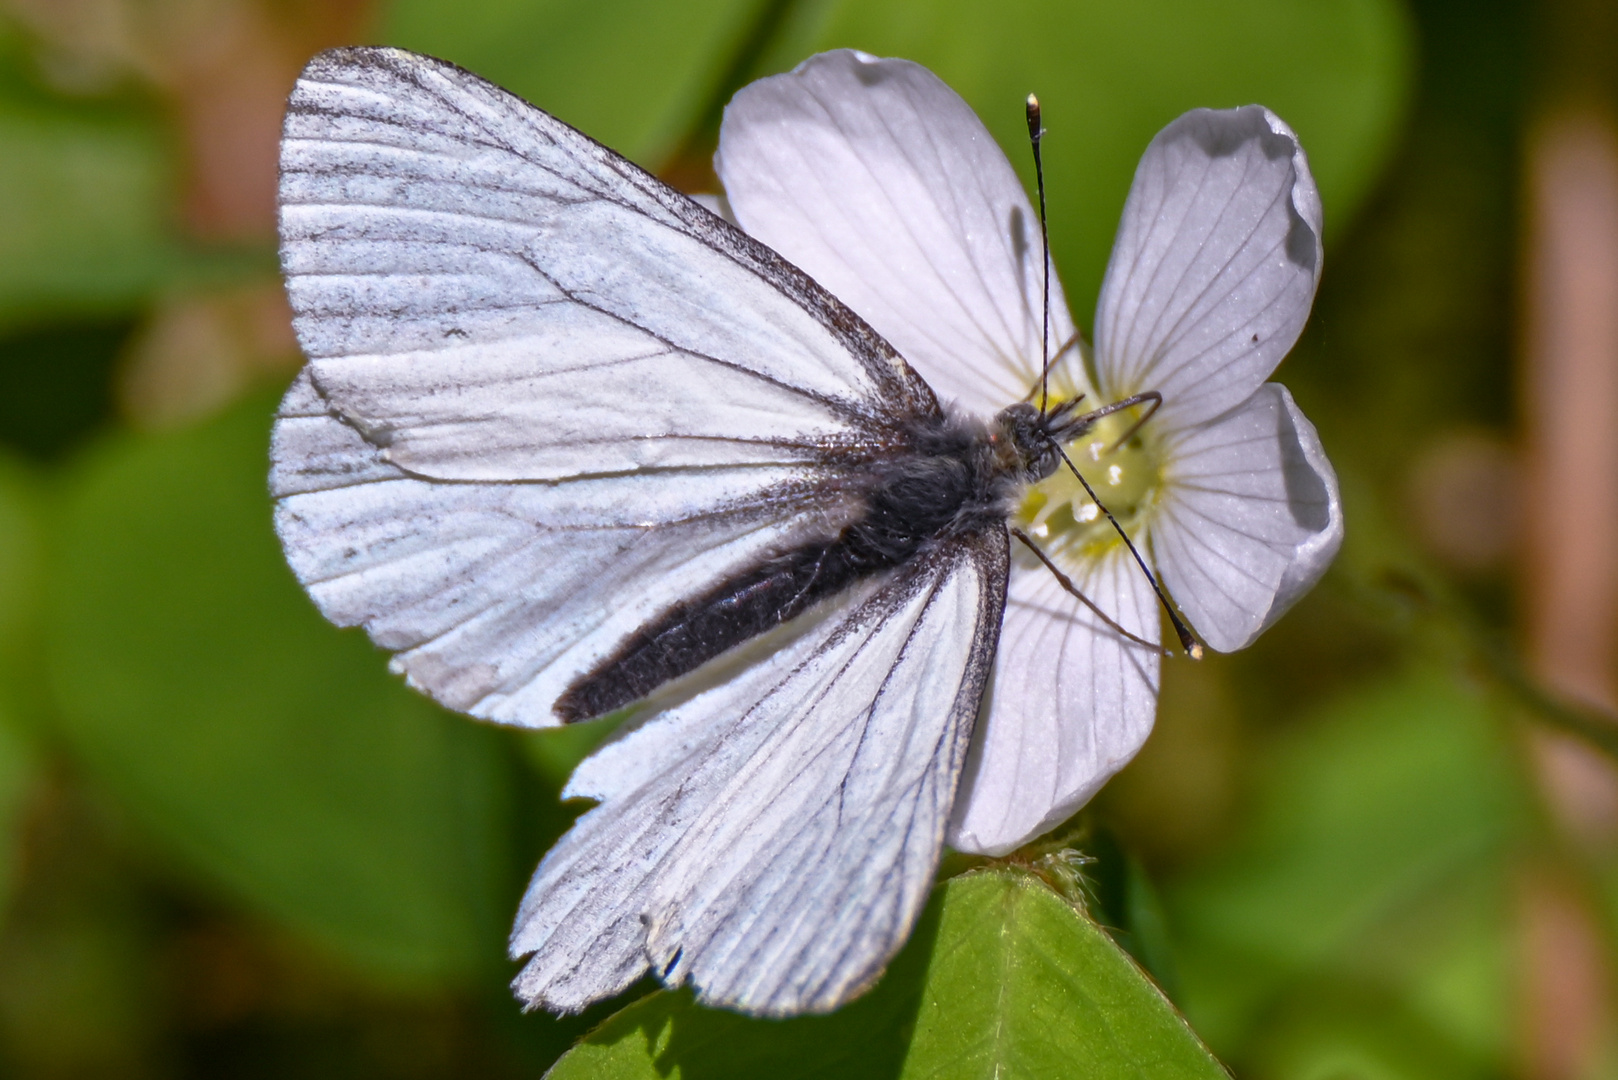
[1152, 382, 1343, 653]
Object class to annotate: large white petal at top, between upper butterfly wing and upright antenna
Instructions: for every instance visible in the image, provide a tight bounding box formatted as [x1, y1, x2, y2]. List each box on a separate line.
[714, 49, 1076, 416]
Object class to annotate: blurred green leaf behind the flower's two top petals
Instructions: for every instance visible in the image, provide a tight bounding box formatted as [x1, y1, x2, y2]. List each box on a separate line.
[764, 0, 1411, 325]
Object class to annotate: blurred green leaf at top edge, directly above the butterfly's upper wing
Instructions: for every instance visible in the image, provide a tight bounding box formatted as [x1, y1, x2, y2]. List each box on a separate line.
[383, 0, 767, 165]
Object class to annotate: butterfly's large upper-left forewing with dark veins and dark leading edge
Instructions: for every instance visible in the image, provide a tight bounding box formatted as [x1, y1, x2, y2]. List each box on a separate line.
[280, 50, 932, 481]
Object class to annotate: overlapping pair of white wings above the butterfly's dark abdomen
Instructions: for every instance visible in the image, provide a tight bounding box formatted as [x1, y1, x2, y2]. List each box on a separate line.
[273, 49, 937, 725]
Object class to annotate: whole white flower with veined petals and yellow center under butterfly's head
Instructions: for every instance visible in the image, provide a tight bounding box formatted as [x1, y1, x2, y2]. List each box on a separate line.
[715, 50, 1343, 853]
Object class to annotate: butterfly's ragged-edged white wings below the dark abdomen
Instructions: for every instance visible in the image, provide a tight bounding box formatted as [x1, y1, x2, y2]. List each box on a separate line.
[511, 531, 1006, 1015]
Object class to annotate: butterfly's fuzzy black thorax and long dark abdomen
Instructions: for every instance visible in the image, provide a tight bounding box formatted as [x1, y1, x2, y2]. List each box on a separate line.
[553, 415, 1010, 724]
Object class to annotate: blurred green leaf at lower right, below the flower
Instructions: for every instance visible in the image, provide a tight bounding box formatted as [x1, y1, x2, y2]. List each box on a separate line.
[1170, 672, 1532, 1052]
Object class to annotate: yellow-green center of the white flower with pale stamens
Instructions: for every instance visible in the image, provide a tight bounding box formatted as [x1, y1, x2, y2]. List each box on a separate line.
[1011, 408, 1163, 559]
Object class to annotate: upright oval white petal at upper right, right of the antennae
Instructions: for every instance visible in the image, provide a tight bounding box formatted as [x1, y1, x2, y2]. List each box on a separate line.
[1095, 105, 1320, 426]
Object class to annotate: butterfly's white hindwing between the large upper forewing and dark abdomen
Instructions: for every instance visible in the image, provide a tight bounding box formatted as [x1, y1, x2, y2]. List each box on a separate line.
[272, 367, 837, 725]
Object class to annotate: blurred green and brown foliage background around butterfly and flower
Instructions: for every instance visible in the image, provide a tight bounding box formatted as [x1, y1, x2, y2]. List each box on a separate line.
[0, 0, 1618, 1080]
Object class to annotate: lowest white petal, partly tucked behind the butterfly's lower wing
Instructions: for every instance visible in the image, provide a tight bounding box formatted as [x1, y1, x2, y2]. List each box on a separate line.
[948, 544, 1160, 855]
